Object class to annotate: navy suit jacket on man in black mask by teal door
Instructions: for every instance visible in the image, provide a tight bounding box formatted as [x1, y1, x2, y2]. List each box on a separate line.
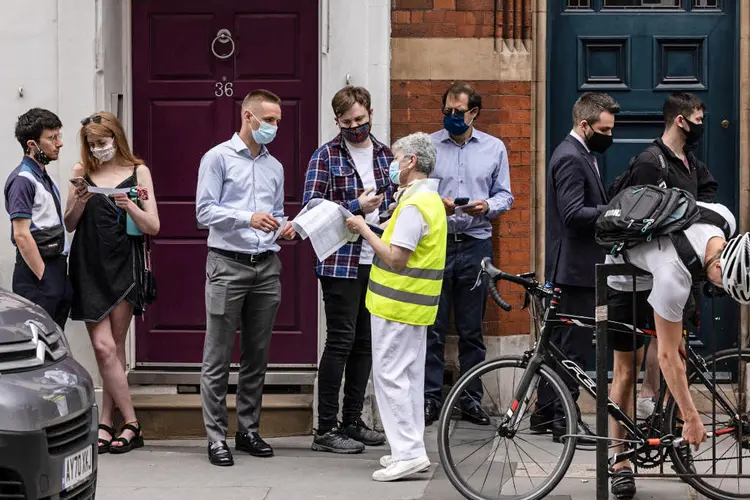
[544, 134, 607, 288]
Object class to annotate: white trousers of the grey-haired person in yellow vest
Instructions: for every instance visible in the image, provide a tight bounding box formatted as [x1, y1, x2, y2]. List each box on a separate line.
[371, 315, 427, 460]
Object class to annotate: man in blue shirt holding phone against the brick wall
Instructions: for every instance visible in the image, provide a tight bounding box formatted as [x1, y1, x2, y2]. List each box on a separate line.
[425, 82, 513, 425]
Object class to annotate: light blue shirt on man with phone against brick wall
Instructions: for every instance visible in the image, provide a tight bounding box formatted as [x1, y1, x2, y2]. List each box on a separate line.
[430, 129, 513, 239]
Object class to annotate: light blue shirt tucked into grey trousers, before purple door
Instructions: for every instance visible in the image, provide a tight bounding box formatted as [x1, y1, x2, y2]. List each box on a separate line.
[195, 134, 284, 254]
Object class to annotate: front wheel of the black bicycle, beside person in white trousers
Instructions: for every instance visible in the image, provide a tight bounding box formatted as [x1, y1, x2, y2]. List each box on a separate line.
[438, 357, 577, 500]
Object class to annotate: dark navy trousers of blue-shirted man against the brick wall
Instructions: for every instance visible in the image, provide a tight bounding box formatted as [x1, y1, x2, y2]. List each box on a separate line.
[424, 239, 492, 409]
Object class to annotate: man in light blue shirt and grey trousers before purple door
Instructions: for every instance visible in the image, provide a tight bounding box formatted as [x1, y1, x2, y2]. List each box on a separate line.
[196, 90, 295, 466]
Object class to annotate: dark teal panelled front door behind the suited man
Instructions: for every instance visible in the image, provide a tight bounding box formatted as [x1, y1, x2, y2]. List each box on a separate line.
[547, 0, 740, 370]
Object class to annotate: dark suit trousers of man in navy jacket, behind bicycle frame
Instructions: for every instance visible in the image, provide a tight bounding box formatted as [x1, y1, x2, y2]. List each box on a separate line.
[537, 285, 596, 421]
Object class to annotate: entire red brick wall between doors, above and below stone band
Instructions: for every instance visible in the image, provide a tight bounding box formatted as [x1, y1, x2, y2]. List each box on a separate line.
[391, 0, 533, 335]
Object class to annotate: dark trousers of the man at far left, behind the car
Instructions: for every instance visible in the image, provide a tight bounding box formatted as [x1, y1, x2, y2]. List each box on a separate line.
[13, 252, 73, 330]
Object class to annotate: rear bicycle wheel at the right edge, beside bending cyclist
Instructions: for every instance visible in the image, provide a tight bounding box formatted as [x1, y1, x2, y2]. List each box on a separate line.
[665, 349, 750, 500]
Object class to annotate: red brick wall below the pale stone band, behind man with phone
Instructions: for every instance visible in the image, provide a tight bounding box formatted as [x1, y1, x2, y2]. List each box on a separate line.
[391, 80, 532, 335]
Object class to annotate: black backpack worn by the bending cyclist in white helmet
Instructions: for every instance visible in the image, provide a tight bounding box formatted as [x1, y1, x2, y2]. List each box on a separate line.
[595, 185, 730, 281]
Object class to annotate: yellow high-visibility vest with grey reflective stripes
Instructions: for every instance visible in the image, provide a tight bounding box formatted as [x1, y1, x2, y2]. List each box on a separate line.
[365, 186, 448, 326]
